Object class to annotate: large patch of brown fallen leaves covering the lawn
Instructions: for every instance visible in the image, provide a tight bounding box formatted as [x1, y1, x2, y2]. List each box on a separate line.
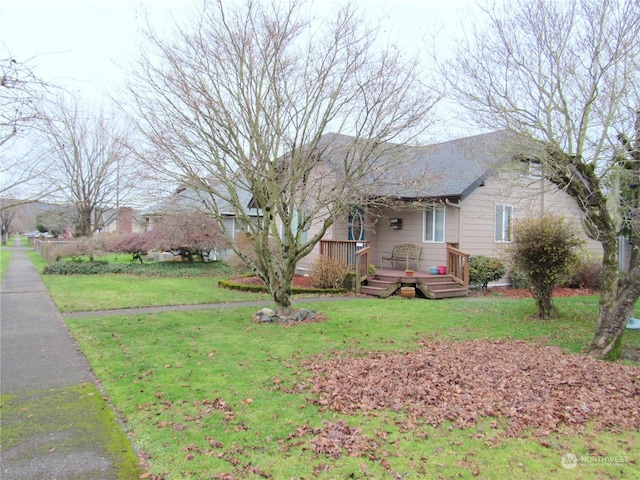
[305, 340, 640, 436]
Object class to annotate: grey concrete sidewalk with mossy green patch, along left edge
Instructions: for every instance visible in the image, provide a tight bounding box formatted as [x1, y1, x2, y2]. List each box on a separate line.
[0, 247, 143, 480]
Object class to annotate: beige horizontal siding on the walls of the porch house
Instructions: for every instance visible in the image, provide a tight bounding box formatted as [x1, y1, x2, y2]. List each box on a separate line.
[299, 168, 602, 271]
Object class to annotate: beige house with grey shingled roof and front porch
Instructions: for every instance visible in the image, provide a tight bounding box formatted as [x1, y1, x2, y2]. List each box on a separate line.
[299, 131, 602, 281]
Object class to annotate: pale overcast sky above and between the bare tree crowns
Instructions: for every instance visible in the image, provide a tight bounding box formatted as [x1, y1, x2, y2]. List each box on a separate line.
[0, 0, 475, 139]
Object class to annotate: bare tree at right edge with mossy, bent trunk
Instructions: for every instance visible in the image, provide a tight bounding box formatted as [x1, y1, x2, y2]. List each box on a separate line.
[446, 0, 640, 358]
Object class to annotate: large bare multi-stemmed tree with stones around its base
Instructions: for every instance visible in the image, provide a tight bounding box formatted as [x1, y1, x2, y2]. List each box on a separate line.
[130, 0, 439, 315]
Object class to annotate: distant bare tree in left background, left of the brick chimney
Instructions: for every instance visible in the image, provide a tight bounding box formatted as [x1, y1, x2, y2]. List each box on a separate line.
[44, 97, 135, 236]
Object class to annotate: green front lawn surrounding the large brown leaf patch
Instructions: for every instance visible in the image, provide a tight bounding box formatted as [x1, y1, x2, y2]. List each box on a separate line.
[66, 298, 640, 479]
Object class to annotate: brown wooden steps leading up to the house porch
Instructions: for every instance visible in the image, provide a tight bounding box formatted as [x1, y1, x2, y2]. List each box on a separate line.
[360, 268, 469, 300]
